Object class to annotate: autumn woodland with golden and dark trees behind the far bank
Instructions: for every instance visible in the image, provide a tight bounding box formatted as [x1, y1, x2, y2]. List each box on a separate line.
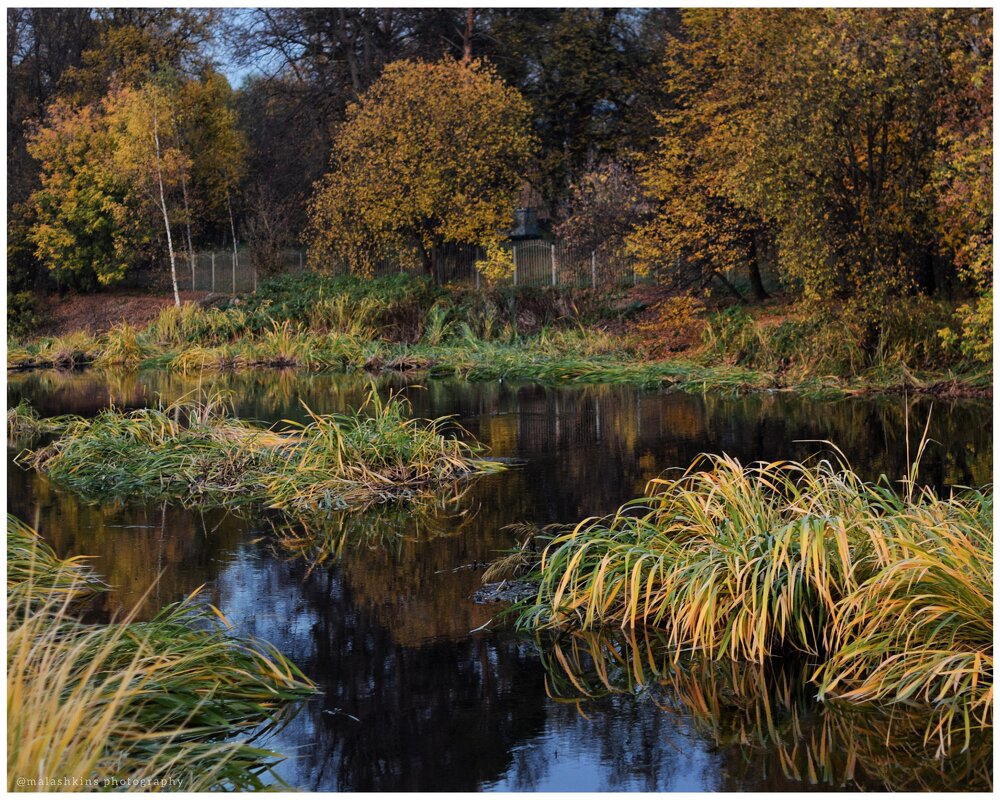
[7, 8, 992, 361]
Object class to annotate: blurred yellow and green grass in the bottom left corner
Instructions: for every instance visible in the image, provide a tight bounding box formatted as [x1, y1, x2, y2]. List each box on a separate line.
[7, 517, 312, 791]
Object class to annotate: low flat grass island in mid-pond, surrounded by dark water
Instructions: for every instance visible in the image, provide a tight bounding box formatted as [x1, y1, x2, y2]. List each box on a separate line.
[20, 388, 502, 511]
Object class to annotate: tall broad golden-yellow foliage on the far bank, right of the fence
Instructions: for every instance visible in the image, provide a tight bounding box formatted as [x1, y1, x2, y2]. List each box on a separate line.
[638, 9, 991, 344]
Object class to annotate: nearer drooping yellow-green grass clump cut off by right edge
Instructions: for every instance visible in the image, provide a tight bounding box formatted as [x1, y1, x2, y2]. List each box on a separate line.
[819, 493, 993, 750]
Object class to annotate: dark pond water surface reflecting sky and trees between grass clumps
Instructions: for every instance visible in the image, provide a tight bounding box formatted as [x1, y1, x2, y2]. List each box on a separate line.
[8, 371, 992, 791]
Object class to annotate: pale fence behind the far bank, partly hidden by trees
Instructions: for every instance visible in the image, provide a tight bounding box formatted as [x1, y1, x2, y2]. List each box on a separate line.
[156, 239, 641, 294]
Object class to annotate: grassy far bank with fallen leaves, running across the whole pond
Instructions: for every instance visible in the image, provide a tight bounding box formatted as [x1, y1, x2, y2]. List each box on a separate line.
[7, 276, 993, 397]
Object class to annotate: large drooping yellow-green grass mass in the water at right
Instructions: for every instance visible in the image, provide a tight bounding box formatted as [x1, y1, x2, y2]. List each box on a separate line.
[519, 457, 993, 743]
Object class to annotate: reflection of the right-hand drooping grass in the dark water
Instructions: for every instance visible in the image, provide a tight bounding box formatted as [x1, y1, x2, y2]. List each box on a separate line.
[539, 631, 993, 791]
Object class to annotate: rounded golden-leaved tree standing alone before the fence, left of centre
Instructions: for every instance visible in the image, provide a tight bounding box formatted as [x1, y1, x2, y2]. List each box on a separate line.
[310, 59, 532, 275]
